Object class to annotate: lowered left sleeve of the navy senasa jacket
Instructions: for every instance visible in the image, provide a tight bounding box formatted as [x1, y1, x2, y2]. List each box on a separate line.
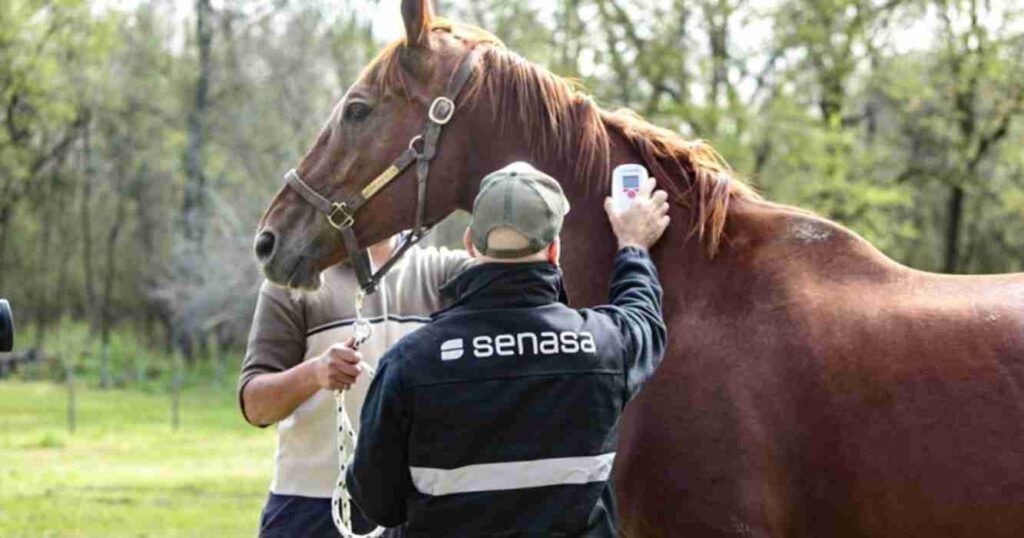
[346, 345, 412, 527]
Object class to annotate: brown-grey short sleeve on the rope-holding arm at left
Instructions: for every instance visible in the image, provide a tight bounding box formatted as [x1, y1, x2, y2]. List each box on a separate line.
[239, 281, 306, 422]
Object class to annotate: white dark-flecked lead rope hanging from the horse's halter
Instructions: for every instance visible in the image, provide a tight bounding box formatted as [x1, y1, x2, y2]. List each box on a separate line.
[331, 290, 384, 538]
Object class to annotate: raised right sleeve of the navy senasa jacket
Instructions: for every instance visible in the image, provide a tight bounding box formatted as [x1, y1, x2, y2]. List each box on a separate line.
[595, 247, 668, 399]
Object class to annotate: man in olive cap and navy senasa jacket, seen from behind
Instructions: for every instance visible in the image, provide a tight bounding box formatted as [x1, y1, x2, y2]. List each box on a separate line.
[347, 164, 669, 537]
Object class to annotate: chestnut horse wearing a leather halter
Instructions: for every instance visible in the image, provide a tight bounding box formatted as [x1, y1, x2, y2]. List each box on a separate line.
[253, 0, 1024, 537]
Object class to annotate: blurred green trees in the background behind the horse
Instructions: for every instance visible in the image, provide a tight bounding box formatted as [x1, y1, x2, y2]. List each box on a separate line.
[0, 0, 1024, 368]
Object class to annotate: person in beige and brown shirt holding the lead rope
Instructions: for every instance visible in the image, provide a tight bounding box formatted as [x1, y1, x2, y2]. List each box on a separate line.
[239, 238, 472, 538]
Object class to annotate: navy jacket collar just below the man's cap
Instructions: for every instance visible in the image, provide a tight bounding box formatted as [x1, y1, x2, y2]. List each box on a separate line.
[438, 261, 568, 314]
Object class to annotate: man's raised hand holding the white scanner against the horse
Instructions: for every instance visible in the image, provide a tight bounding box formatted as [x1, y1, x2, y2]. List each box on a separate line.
[604, 177, 669, 250]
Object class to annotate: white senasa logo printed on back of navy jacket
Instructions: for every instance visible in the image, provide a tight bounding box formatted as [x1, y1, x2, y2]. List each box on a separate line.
[441, 331, 597, 361]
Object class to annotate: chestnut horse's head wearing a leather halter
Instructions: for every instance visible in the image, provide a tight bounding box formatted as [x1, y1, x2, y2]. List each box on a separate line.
[255, 0, 494, 289]
